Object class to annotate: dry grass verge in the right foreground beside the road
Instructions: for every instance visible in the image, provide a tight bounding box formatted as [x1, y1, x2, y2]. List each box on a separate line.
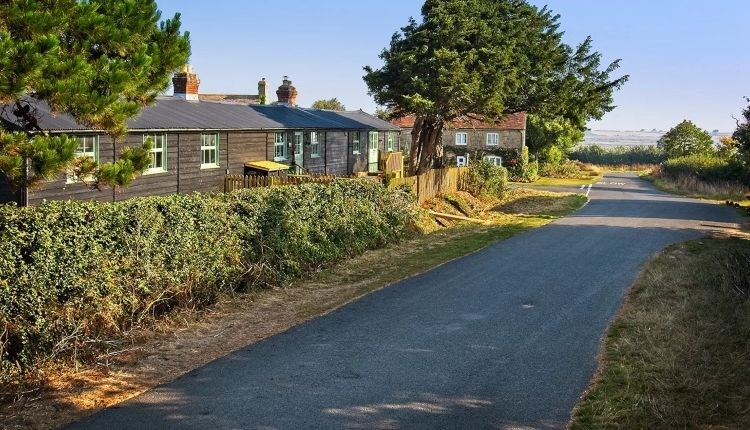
[570, 238, 750, 429]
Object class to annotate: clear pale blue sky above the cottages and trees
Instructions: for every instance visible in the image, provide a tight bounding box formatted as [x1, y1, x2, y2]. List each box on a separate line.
[157, 0, 750, 131]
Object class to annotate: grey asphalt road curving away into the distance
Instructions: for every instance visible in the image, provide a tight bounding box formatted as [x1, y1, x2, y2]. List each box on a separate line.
[71, 174, 740, 430]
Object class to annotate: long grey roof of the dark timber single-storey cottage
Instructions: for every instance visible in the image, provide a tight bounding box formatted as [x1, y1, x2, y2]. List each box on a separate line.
[0, 97, 400, 132]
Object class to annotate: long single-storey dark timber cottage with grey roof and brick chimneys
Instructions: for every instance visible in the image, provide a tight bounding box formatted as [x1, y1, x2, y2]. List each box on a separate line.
[0, 68, 400, 205]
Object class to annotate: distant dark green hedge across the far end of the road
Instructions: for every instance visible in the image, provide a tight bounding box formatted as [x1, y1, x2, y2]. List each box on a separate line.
[570, 145, 666, 166]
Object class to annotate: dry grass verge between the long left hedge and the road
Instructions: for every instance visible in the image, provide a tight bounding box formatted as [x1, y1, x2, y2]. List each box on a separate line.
[0, 189, 586, 429]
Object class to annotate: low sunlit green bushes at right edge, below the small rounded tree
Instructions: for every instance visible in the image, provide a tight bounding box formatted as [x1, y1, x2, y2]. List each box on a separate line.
[662, 154, 750, 185]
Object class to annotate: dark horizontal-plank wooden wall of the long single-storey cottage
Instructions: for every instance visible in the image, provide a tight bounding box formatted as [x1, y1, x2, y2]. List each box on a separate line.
[8, 130, 403, 205]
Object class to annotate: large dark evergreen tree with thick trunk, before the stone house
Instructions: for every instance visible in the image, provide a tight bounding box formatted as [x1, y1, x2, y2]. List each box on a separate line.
[364, 0, 627, 173]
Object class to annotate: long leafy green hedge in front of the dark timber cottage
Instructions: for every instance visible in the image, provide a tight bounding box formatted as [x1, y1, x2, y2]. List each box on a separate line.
[0, 180, 416, 385]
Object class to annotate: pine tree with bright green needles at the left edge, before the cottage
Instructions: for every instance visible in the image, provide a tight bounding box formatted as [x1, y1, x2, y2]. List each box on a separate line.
[0, 0, 190, 187]
